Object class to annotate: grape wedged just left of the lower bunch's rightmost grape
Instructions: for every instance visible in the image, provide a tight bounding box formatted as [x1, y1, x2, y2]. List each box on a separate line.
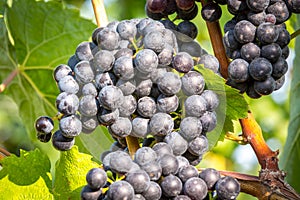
[199, 168, 221, 190]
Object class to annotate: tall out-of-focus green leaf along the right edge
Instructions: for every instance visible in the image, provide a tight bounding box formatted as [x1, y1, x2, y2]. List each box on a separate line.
[280, 15, 300, 192]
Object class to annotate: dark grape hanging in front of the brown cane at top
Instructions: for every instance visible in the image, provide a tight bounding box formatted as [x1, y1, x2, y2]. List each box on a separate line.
[201, 2, 222, 22]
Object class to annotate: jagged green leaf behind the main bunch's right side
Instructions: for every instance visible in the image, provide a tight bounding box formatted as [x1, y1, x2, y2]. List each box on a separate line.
[196, 65, 248, 148]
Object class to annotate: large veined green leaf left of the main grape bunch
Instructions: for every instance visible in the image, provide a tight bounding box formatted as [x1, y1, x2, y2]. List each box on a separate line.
[0, 0, 96, 140]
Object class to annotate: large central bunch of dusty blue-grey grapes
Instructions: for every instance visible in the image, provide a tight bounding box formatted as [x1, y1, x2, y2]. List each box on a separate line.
[36, 18, 219, 162]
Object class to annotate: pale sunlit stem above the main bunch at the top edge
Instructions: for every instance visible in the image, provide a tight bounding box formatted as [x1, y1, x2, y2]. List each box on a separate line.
[92, 0, 108, 27]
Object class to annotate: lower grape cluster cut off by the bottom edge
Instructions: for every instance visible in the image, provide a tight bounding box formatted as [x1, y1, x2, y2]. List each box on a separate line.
[81, 142, 240, 200]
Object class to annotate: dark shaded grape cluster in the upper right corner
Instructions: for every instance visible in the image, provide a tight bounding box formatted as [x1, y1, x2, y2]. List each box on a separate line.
[223, 0, 299, 98]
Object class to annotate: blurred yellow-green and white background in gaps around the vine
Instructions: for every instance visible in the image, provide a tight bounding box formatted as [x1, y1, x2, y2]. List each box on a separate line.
[0, 0, 294, 199]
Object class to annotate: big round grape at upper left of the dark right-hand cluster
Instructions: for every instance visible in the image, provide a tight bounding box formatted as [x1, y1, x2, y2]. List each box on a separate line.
[234, 20, 256, 44]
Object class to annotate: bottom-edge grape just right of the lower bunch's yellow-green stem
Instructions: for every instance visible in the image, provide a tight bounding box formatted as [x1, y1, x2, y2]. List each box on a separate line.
[107, 180, 134, 200]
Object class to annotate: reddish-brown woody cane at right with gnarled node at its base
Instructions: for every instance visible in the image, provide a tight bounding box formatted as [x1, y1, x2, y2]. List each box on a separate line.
[201, 0, 300, 199]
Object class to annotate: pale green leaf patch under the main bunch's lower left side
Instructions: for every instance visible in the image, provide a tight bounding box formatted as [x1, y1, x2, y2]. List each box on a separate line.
[76, 126, 114, 162]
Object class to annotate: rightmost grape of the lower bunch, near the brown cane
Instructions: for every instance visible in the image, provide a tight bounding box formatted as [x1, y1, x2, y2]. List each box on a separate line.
[216, 176, 240, 199]
